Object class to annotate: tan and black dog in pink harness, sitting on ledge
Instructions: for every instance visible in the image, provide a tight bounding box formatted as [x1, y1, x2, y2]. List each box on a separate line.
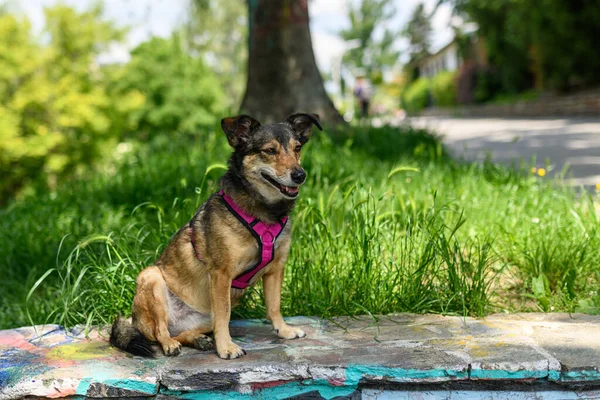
[110, 113, 323, 359]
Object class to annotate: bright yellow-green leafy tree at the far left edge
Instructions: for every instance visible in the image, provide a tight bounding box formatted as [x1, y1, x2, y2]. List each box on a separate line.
[0, 6, 135, 203]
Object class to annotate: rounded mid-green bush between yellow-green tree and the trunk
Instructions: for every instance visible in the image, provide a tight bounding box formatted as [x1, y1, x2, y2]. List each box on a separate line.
[111, 34, 225, 138]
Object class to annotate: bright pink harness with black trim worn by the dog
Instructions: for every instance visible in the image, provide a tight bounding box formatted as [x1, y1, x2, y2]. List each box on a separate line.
[190, 190, 288, 289]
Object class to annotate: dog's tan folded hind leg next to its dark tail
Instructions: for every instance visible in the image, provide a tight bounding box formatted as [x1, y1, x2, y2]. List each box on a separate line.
[133, 266, 181, 356]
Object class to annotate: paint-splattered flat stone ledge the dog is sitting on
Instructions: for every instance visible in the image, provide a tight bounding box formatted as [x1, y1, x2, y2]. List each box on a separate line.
[0, 314, 600, 399]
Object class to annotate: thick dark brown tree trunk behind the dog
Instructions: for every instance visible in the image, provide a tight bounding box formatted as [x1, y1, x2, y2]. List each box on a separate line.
[241, 0, 344, 127]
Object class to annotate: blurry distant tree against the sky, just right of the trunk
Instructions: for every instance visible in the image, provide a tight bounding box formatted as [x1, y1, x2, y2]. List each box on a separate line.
[340, 0, 400, 83]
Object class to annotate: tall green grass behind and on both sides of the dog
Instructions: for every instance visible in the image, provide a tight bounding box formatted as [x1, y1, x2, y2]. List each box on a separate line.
[0, 124, 600, 328]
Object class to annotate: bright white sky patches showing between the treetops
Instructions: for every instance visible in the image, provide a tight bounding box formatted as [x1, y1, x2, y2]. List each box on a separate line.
[14, 0, 452, 73]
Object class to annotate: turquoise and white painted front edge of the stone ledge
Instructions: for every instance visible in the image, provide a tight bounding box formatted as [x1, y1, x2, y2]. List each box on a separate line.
[0, 363, 600, 398]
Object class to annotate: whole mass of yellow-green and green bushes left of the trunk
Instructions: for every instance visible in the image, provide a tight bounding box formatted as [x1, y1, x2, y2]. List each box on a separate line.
[0, 6, 231, 204]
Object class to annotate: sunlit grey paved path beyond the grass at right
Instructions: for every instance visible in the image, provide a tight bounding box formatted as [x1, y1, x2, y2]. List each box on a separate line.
[409, 116, 600, 188]
